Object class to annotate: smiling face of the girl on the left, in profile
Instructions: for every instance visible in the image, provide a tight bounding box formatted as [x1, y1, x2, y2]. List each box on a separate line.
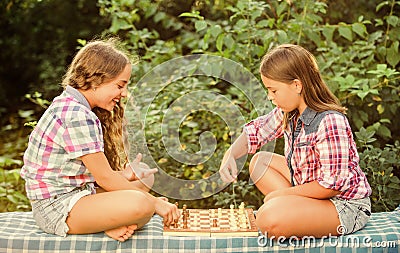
[89, 64, 132, 111]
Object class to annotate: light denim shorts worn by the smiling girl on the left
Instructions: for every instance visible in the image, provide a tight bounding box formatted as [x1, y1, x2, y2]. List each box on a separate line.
[31, 185, 92, 237]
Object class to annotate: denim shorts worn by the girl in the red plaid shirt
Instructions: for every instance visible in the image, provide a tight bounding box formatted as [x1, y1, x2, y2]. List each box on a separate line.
[330, 197, 371, 235]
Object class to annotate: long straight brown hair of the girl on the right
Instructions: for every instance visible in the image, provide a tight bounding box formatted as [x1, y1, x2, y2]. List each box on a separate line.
[260, 44, 346, 129]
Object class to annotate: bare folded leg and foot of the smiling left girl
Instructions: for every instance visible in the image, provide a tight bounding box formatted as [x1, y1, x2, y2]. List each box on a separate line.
[67, 190, 155, 241]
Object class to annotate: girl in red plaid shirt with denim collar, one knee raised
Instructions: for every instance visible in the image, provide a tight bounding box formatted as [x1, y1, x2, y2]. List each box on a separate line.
[220, 44, 371, 238]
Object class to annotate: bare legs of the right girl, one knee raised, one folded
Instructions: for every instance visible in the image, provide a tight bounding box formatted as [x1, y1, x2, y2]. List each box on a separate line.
[249, 152, 340, 238]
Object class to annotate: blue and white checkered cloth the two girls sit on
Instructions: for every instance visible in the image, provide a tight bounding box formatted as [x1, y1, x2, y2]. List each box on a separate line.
[0, 211, 400, 253]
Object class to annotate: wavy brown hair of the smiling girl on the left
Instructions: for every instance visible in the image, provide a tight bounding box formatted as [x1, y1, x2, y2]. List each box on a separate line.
[62, 38, 131, 170]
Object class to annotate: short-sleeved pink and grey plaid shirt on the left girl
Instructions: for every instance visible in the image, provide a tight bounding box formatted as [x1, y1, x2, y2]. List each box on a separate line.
[21, 87, 104, 199]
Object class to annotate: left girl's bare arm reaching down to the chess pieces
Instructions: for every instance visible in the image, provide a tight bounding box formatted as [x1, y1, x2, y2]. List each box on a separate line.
[81, 152, 180, 225]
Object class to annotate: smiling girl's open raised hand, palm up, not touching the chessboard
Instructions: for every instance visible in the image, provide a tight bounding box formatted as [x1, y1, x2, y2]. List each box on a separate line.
[122, 153, 158, 181]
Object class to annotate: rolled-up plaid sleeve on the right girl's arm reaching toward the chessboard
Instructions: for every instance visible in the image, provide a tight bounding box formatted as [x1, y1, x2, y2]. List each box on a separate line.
[243, 108, 283, 154]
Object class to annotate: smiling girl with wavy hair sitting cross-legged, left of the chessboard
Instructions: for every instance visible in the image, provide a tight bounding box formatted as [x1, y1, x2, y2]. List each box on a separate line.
[21, 39, 179, 241]
